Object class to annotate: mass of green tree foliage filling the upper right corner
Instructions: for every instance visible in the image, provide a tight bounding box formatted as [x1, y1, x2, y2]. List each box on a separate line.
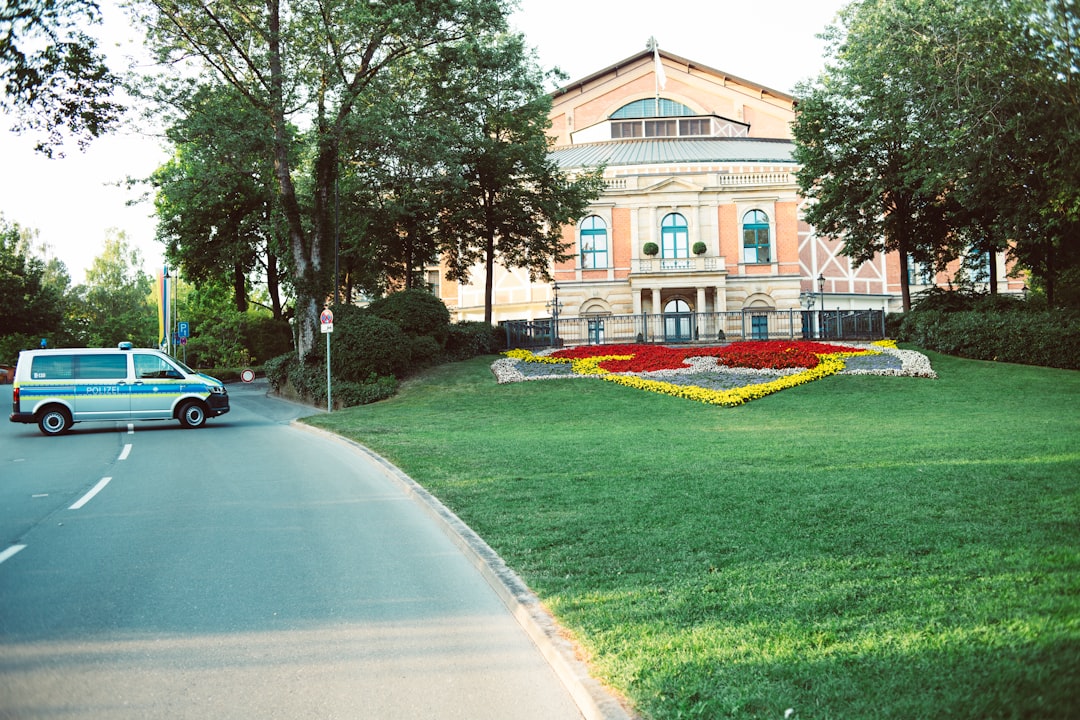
[793, 0, 1080, 309]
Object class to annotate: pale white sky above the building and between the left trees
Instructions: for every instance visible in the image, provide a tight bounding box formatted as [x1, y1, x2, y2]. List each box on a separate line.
[0, 0, 849, 283]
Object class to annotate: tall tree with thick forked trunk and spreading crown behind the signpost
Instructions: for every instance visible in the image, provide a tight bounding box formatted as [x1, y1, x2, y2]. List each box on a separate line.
[139, 0, 505, 355]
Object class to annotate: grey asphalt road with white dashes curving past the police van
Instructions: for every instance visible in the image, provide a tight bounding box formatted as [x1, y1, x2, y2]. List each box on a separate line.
[0, 384, 582, 720]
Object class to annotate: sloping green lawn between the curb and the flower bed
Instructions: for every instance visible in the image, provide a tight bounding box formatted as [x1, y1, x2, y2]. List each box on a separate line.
[308, 353, 1080, 720]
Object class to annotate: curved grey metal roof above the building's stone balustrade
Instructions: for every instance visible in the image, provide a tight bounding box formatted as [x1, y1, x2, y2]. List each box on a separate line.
[550, 137, 795, 168]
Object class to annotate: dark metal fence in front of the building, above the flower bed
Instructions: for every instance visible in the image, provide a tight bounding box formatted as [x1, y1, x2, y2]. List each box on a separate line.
[500, 310, 885, 348]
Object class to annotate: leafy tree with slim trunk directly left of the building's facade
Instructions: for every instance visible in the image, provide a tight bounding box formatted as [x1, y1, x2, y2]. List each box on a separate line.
[440, 35, 603, 323]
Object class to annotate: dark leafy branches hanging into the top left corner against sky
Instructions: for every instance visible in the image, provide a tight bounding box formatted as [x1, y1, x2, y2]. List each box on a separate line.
[0, 0, 122, 155]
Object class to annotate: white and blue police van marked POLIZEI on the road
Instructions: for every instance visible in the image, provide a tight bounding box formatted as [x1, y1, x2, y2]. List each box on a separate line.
[10, 342, 229, 435]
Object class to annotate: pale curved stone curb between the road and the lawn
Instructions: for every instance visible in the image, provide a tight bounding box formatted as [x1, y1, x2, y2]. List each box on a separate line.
[292, 420, 636, 720]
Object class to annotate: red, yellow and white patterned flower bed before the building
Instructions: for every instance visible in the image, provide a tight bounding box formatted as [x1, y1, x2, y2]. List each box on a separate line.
[491, 340, 936, 407]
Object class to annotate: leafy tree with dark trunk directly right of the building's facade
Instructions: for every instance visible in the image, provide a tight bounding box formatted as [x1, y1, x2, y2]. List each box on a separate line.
[793, 0, 957, 310]
